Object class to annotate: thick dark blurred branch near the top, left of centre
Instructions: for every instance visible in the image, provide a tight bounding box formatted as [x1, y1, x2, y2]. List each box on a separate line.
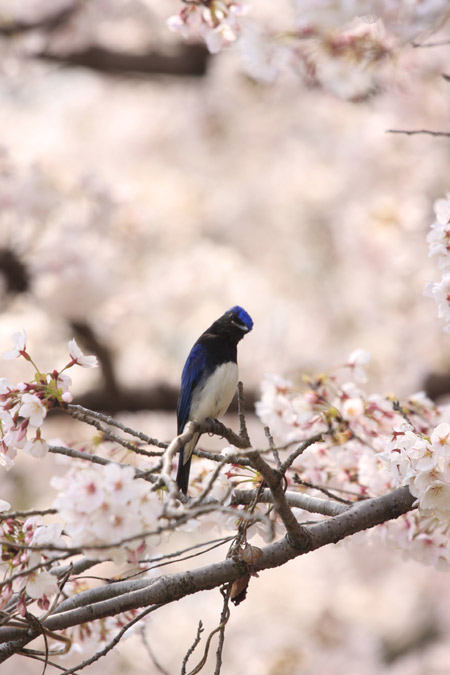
[36, 44, 209, 77]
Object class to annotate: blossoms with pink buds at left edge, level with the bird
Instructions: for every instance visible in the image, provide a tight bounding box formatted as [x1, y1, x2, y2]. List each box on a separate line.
[0, 331, 97, 469]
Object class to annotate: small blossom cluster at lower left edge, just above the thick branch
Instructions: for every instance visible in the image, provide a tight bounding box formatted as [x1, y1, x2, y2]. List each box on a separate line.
[0, 516, 65, 615]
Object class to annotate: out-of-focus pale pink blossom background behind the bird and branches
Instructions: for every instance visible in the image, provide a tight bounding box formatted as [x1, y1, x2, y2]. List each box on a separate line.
[0, 0, 450, 675]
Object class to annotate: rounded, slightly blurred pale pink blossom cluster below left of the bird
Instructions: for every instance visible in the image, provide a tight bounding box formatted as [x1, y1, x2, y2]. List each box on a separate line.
[52, 462, 161, 563]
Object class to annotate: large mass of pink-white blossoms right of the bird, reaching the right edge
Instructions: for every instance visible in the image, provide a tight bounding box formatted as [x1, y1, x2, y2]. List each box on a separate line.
[257, 350, 450, 565]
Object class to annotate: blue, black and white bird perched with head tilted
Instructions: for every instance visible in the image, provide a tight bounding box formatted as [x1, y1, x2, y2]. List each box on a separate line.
[177, 305, 253, 494]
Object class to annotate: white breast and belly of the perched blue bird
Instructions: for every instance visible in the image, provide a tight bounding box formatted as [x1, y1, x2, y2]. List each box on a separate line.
[189, 361, 239, 422]
